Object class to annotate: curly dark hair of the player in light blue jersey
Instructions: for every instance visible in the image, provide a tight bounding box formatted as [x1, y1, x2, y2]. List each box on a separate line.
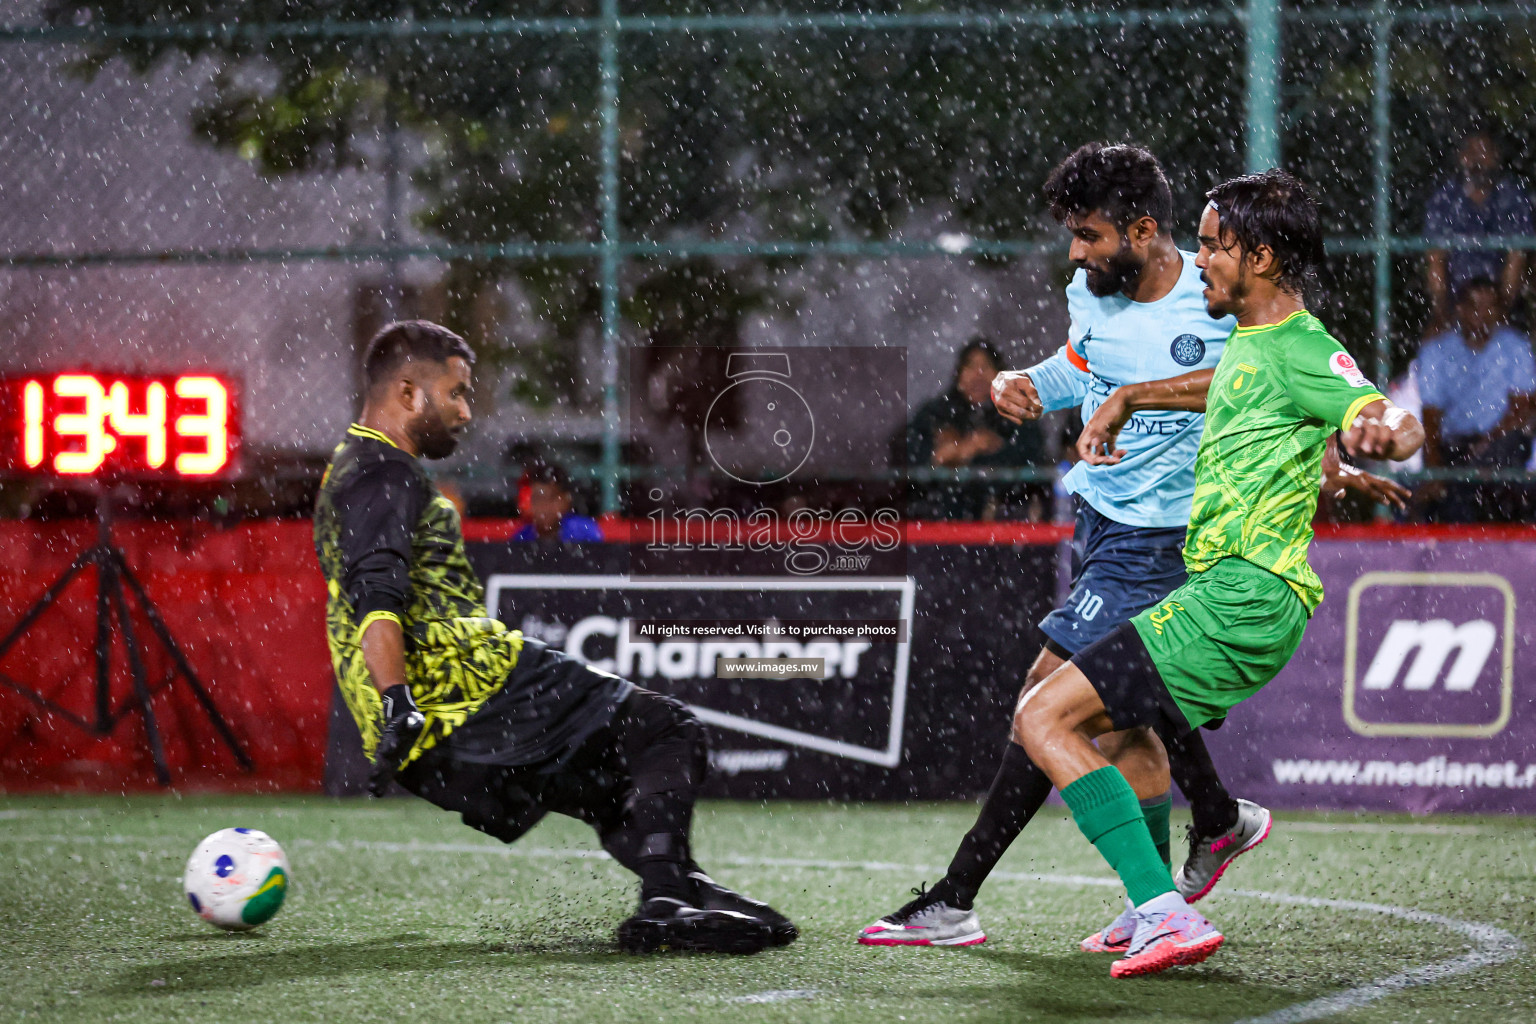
[1044, 143, 1174, 233]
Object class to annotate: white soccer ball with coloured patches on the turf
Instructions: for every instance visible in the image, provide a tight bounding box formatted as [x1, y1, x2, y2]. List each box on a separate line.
[181, 829, 289, 932]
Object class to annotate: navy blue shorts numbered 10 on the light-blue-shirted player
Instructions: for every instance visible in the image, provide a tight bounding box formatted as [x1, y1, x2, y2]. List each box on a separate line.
[1040, 494, 1187, 657]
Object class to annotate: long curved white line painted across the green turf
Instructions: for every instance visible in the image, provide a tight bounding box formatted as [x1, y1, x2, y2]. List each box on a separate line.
[0, 834, 1525, 1024]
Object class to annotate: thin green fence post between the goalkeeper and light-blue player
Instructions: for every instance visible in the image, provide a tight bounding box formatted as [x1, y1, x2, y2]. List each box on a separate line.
[598, 0, 621, 513]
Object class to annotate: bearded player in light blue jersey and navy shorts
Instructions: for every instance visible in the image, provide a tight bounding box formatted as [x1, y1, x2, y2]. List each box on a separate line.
[859, 143, 1390, 952]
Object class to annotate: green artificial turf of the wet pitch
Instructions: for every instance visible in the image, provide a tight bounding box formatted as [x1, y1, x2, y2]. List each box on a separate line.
[0, 797, 1536, 1024]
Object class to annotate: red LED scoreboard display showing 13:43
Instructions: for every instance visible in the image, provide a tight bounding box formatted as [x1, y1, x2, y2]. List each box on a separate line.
[0, 372, 240, 481]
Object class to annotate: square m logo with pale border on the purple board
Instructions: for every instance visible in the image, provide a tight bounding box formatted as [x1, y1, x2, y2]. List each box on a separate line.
[1344, 573, 1514, 737]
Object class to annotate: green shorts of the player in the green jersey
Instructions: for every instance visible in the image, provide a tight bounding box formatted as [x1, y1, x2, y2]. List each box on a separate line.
[1130, 557, 1307, 728]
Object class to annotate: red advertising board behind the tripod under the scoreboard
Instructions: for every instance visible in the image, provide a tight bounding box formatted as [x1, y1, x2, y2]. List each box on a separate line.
[0, 520, 333, 792]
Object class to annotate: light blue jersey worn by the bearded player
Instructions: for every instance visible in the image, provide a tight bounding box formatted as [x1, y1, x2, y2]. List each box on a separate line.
[1056, 260, 1235, 528]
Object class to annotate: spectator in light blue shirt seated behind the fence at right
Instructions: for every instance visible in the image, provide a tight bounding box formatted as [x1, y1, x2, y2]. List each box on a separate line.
[1418, 276, 1536, 522]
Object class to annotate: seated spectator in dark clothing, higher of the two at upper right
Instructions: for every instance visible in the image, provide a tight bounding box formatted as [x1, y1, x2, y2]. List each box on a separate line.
[1424, 129, 1536, 336]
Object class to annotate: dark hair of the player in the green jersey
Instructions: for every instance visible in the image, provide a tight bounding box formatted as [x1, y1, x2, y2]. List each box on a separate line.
[1206, 169, 1322, 301]
